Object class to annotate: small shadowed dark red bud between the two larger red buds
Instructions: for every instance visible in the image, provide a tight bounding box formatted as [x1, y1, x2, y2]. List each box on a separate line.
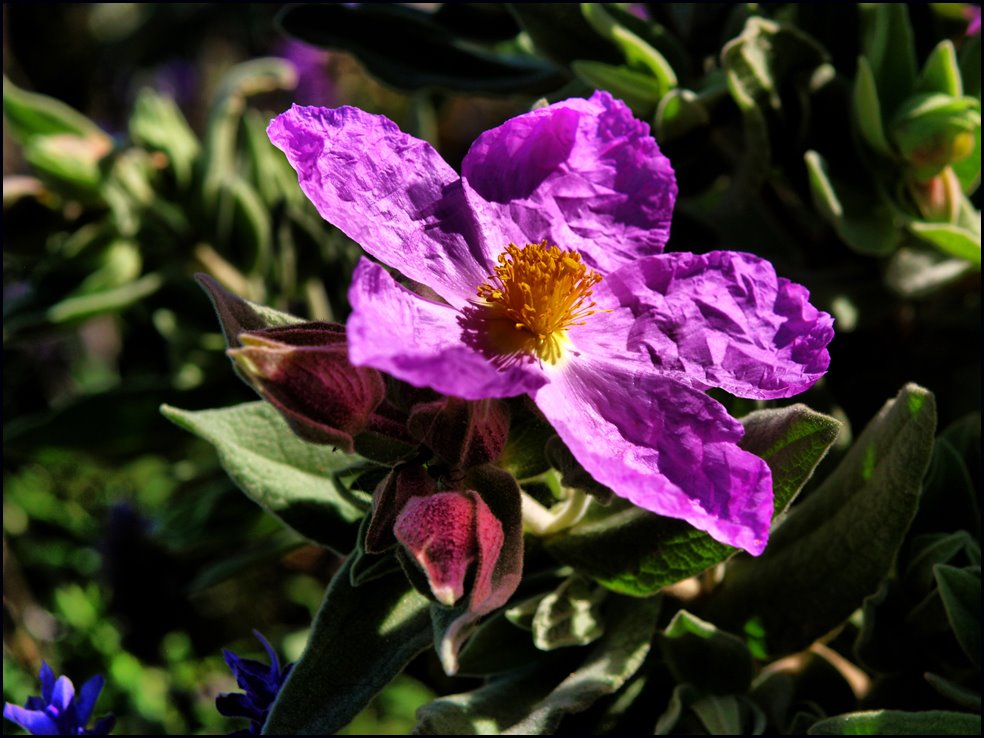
[407, 397, 509, 468]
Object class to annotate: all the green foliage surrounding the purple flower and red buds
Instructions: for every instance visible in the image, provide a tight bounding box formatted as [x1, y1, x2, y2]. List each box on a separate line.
[3, 3, 981, 735]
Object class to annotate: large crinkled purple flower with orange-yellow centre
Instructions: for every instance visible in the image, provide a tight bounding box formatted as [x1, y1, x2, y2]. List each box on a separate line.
[268, 92, 833, 554]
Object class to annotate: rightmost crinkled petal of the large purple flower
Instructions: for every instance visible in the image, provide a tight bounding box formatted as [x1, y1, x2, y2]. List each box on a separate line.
[605, 251, 834, 399]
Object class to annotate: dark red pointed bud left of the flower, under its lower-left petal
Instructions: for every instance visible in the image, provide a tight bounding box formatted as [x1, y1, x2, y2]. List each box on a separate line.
[228, 322, 386, 453]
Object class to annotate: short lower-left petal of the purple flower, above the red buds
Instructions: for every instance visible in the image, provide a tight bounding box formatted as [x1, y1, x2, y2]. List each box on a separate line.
[347, 259, 546, 400]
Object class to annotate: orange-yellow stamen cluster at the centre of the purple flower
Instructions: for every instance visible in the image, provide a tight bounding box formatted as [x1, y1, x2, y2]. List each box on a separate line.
[478, 241, 601, 364]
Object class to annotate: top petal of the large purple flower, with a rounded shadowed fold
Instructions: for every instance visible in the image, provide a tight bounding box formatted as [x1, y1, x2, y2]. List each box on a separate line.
[462, 92, 677, 274]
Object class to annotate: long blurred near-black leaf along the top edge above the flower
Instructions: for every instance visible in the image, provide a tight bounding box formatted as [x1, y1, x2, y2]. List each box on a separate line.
[278, 3, 567, 95]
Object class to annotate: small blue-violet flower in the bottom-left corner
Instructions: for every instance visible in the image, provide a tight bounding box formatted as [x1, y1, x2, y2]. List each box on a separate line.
[3, 661, 116, 735]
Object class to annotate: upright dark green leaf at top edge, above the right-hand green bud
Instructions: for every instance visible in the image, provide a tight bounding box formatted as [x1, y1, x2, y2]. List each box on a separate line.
[860, 3, 916, 118]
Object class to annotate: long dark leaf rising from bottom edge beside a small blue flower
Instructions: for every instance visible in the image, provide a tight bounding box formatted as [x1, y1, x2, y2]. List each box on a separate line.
[263, 562, 431, 735]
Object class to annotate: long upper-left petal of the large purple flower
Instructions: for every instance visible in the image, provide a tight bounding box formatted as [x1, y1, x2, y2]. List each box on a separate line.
[267, 105, 489, 306]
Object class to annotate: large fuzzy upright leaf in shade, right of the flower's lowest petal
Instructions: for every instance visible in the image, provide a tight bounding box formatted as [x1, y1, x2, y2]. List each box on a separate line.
[708, 384, 936, 655]
